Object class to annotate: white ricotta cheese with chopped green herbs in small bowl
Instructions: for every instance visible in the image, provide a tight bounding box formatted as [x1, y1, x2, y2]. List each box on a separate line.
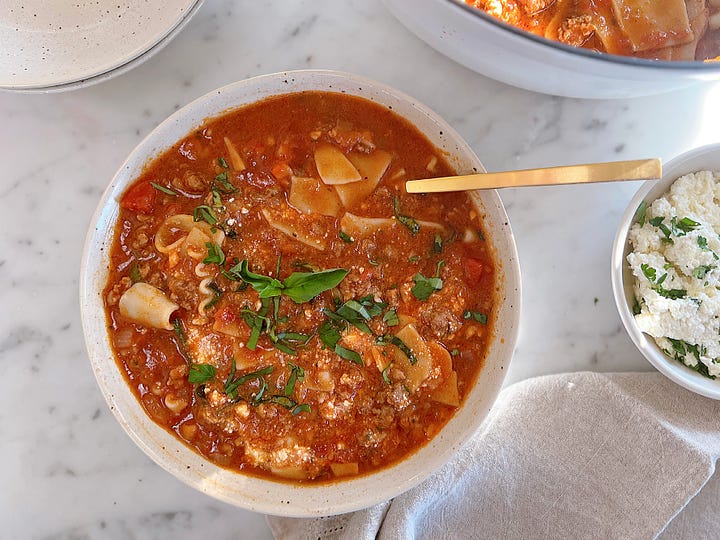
[627, 171, 720, 378]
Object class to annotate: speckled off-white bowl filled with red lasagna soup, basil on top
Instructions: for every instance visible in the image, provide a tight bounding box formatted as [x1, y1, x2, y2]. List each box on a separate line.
[80, 71, 520, 516]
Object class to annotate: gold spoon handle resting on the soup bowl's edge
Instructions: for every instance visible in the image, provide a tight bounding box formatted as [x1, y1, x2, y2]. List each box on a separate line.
[405, 158, 662, 193]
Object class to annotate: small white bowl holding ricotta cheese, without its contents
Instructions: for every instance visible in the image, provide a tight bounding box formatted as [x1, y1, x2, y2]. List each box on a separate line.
[611, 144, 720, 399]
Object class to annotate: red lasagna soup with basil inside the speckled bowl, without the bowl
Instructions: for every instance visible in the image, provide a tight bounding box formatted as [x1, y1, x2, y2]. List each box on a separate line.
[104, 92, 497, 481]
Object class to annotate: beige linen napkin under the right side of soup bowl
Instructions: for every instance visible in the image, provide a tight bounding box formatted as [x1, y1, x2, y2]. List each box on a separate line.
[268, 373, 720, 540]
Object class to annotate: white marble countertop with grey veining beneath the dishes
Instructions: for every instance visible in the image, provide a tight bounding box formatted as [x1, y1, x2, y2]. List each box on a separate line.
[0, 0, 720, 539]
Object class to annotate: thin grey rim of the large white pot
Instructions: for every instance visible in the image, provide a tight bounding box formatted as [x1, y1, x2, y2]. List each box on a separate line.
[442, 0, 720, 73]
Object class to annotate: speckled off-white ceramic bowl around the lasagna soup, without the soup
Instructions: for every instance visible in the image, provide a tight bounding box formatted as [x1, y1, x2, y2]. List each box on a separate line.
[80, 71, 520, 516]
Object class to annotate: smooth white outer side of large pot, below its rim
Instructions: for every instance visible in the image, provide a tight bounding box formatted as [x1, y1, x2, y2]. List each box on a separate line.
[384, 0, 720, 98]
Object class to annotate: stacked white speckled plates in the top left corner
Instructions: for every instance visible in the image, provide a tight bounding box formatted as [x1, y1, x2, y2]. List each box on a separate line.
[0, 0, 199, 90]
